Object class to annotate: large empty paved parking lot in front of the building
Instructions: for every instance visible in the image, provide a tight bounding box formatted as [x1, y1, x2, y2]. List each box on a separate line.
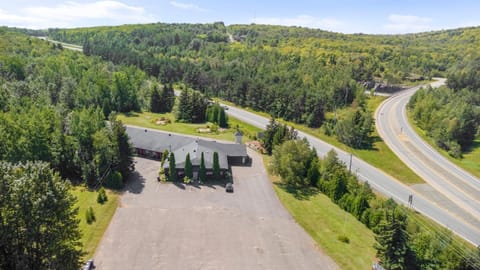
[95, 152, 338, 270]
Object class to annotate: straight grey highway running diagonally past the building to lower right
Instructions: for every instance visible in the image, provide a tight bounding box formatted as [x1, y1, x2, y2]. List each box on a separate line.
[222, 95, 480, 246]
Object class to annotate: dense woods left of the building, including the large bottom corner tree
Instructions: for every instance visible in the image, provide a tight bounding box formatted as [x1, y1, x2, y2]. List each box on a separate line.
[0, 28, 142, 269]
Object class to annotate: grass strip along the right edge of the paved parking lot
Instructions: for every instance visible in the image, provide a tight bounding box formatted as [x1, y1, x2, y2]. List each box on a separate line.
[264, 156, 376, 269]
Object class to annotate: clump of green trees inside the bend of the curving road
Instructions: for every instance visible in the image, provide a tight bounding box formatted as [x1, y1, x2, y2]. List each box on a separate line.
[408, 55, 480, 158]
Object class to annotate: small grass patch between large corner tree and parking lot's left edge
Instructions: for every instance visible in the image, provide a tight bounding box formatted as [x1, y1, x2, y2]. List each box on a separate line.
[72, 186, 119, 259]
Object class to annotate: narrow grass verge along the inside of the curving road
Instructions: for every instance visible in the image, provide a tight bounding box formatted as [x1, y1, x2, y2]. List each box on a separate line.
[407, 113, 480, 178]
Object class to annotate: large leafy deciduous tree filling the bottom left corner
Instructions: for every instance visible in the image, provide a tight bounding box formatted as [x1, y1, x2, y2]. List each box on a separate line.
[0, 162, 81, 269]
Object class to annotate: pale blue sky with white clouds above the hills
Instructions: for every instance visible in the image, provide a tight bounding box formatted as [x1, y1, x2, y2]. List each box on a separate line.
[0, 0, 480, 34]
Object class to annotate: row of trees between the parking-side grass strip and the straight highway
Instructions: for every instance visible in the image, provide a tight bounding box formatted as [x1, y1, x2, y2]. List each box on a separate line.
[270, 139, 480, 269]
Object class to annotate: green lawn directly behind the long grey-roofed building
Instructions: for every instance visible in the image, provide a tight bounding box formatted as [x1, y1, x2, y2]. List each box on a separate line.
[118, 112, 260, 141]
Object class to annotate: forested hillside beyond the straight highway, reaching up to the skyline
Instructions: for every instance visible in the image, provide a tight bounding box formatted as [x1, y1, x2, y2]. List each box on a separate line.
[43, 22, 480, 154]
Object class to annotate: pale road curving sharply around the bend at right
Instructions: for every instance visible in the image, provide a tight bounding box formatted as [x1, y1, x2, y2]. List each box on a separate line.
[375, 79, 480, 233]
